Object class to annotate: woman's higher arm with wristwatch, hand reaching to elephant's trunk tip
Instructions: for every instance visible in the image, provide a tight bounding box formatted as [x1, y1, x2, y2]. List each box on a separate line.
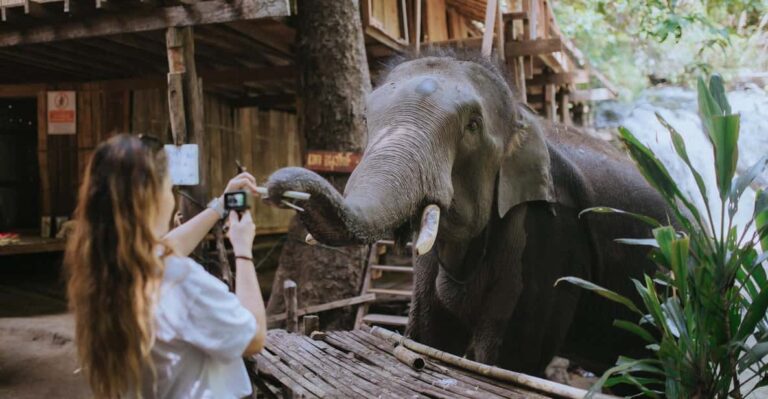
[163, 172, 257, 256]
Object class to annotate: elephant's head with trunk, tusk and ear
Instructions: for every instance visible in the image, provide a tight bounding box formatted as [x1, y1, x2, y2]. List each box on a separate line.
[267, 56, 553, 254]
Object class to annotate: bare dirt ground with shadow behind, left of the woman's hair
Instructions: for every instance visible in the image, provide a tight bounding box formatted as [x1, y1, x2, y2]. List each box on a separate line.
[0, 255, 91, 399]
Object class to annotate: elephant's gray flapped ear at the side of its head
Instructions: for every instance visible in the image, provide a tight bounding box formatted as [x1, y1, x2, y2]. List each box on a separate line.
[497, 113, 555, 218]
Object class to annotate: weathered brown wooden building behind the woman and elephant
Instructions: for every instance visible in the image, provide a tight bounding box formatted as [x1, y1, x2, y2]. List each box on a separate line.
[0, 0, 610, 254]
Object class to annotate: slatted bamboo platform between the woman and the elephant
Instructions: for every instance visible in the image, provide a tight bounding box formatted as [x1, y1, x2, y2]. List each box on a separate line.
[254, 327, 604, 399]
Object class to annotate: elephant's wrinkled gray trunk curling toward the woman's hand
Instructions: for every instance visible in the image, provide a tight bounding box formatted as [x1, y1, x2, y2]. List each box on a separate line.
[267, 129, 451, 250]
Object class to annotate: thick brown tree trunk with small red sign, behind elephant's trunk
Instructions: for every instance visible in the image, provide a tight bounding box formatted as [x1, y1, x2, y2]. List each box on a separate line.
[267, 0, 371, 329]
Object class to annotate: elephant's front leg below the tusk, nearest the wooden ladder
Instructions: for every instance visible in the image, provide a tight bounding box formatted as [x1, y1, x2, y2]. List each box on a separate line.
[406, 254, 468, 356]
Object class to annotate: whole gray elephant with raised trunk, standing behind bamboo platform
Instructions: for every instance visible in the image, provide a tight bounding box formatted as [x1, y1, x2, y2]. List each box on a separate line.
[267, 57, 666, 375]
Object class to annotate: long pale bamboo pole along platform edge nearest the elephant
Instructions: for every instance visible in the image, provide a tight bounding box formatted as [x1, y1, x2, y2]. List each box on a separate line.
[371, 327, 616, 399]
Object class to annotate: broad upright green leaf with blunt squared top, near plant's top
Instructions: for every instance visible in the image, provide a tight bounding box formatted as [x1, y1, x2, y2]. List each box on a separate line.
[711, 115, 740, 200]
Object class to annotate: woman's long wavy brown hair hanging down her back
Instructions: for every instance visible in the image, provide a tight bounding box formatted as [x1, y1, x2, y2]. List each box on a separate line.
[64, 134, 167, 398]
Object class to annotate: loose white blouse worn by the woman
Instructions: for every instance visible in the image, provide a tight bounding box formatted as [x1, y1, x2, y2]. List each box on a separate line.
[142, 256, 256, 399]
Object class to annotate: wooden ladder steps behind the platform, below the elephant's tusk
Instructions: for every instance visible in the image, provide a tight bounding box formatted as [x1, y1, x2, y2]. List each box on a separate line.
[355, 240, 413, 329]
